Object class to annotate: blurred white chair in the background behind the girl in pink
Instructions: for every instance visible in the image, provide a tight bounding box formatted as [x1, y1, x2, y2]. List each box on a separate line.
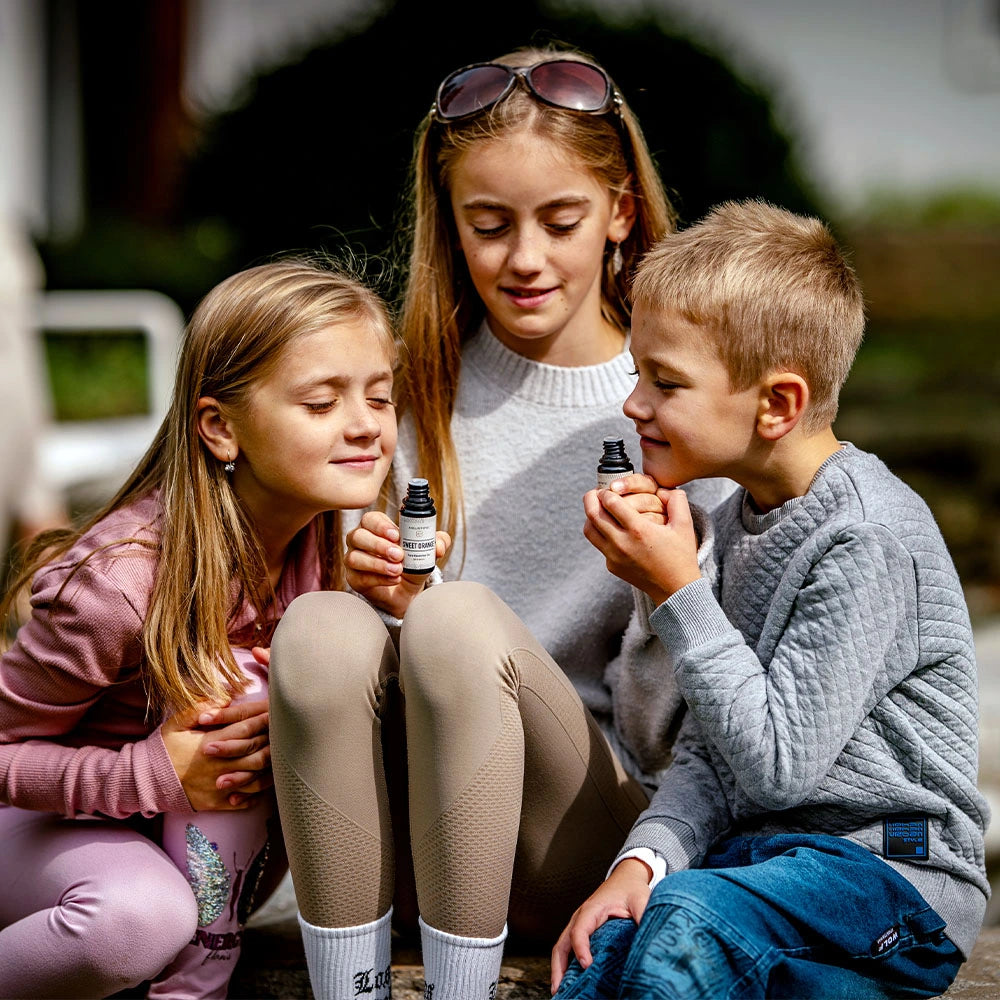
[36, 290, 184, 502]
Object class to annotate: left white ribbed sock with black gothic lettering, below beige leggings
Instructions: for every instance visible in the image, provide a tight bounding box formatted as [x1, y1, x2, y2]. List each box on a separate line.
[299, 907, 392, 1000]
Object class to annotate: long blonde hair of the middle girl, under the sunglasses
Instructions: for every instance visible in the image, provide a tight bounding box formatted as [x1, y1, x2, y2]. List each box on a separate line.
[394, 47, 675, 548]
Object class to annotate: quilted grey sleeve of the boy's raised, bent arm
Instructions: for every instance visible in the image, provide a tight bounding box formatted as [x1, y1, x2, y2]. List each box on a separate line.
[651, 524, 918, 810]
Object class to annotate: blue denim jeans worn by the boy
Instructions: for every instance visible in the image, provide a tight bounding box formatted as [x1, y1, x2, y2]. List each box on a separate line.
[556, 834, 962, 1000]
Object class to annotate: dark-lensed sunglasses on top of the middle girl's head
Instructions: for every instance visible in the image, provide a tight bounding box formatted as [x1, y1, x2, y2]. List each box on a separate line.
[431, 59, 622, 122]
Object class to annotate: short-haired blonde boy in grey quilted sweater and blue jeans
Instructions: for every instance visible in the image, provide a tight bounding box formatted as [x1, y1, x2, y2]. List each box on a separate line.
[553, 202, 989, 998]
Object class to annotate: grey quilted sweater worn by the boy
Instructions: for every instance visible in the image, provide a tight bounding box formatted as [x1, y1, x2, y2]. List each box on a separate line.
[623, 445, 989, 956]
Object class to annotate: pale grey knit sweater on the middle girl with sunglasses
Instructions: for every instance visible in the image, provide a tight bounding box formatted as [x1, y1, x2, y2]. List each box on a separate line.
[390, 323, 735, 780]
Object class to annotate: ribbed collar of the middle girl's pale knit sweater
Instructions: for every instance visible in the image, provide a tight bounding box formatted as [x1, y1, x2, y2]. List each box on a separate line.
[462, 321, 635, 407]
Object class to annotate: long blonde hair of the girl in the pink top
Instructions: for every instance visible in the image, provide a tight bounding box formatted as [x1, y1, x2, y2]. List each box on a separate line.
[0, 258, 395, 711]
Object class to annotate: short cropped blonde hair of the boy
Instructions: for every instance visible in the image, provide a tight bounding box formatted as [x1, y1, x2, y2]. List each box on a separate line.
[632, 201, 865, 432]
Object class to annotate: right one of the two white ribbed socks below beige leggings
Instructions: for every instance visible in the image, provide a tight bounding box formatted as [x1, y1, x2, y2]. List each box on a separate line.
[420, 917, 507, 1000]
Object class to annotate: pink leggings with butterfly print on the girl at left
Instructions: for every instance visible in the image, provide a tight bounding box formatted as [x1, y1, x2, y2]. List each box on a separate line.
[0, 650, 273, 1000]
